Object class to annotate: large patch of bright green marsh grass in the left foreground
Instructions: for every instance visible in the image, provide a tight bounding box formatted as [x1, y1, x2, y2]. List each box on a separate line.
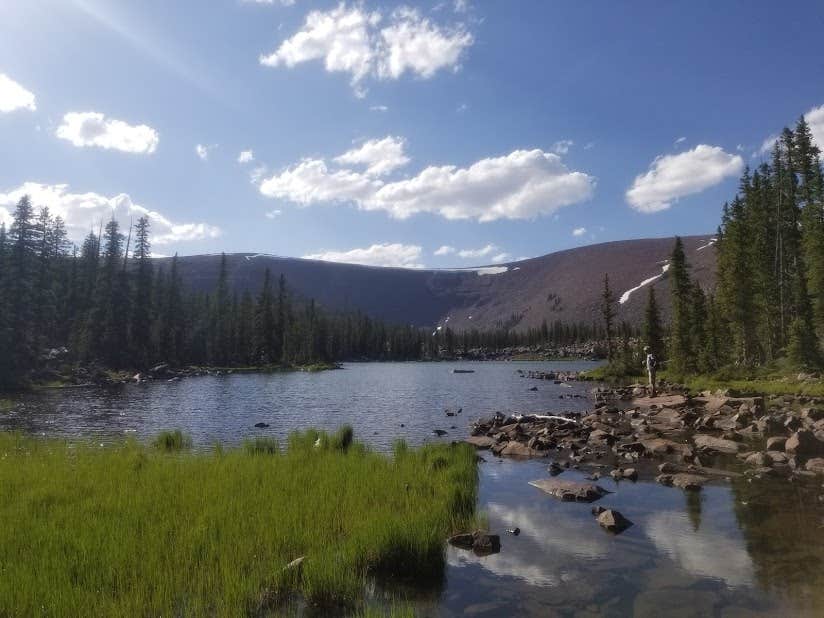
[0, 429, 477, 616]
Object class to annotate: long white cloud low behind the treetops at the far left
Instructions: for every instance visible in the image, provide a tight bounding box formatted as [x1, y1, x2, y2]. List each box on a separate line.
[0, 182, 220, 245]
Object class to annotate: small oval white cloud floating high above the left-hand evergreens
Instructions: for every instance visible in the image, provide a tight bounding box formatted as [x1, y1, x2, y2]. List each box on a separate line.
[57, 112, 160, 154]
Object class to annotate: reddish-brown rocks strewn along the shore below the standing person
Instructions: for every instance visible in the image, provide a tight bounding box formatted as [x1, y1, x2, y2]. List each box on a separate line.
[466, 382, 824, 501]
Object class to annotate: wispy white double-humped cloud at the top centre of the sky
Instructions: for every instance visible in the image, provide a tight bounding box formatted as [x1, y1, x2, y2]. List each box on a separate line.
[260, 2, 473, 95]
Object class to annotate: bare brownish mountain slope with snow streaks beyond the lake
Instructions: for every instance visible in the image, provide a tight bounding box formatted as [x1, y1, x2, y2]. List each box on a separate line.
[157, 236, 715, 330]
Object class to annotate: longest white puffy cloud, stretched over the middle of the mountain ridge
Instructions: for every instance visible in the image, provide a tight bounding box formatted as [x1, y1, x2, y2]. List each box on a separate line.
[260, 143, 595, 221]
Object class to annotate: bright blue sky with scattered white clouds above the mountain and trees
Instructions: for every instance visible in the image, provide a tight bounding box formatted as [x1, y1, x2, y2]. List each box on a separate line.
[0, 0, 824, 267]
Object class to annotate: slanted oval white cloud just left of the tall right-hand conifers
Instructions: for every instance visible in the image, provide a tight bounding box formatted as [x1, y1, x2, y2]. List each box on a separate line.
[626, 144, 744, 213]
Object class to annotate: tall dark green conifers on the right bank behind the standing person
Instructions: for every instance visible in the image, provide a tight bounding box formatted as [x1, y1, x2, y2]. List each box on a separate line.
[602, 117, 824, 376]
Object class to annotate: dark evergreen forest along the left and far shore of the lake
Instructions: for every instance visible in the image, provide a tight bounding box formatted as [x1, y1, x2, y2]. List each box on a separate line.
[0, 197, 599, 388]
